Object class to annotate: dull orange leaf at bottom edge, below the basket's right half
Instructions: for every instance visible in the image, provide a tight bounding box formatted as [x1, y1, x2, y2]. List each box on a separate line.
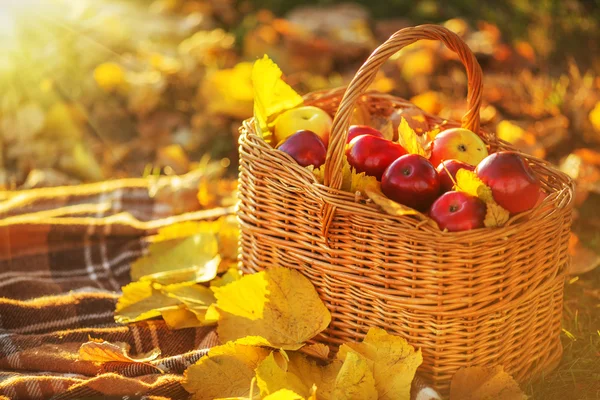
[450, 366, 527, 400]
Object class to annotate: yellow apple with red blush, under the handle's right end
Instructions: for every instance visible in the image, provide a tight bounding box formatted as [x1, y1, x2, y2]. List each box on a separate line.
[429, 128, 488, 167]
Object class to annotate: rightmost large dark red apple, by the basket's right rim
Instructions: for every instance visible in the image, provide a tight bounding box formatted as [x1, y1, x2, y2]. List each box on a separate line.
[475, 151, 541, 214]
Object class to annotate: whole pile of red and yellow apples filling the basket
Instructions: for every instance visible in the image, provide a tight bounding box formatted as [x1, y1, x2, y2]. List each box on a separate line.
[274, 106, 545, 232]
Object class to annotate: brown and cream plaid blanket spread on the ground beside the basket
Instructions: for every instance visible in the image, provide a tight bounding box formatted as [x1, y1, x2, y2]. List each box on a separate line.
[0, 171, 437, 400]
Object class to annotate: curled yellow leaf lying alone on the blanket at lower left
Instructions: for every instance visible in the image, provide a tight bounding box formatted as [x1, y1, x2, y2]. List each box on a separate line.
[79, 338, 160, 363]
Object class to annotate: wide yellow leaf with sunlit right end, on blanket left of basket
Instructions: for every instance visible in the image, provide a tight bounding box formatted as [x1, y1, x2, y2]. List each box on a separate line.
[131, 232, 219, 282]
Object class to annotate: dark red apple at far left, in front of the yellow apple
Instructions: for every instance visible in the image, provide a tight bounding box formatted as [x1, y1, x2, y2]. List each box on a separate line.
[277, 130, 327, 168]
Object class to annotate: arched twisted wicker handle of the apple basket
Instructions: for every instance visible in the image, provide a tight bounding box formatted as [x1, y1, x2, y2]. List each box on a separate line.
[322, 25, 482, 237]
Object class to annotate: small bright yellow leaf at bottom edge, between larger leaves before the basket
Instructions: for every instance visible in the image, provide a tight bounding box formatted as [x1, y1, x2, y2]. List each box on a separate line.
[256, 353, 312, 397]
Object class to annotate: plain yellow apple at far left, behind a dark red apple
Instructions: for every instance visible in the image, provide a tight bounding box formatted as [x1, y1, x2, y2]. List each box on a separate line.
[274, 106, 333, 147]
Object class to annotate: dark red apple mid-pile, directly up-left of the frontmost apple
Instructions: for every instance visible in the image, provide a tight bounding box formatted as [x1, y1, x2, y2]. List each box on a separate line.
[381, 154, 440, 211]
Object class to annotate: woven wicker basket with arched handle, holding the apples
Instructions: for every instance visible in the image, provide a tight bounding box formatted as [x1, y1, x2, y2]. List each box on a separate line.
[238, 25, 573, 392]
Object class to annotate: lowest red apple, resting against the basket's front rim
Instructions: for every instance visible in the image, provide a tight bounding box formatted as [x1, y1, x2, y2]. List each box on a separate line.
[429, 191, 486, 232]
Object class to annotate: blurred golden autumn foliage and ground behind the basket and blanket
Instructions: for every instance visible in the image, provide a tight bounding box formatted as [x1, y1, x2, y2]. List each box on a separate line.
[0, 0, 600, 399]
